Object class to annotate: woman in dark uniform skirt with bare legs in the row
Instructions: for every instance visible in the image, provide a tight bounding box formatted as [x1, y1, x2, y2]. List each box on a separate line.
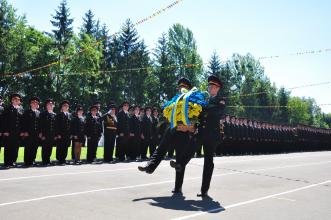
[70, 105, 85, 165]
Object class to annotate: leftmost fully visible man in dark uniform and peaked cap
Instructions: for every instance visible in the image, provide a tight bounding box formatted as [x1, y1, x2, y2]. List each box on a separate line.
[3, 93, 24, 167]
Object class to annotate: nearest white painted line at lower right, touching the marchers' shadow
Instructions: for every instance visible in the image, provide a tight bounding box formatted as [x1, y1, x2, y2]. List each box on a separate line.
[173, 180, 331, 220]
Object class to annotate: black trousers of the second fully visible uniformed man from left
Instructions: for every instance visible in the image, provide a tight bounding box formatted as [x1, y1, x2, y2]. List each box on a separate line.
[24, 135, 40, 166]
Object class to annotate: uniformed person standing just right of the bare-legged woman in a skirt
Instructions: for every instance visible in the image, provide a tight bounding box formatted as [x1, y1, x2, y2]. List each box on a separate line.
[85, 106, 102, 163]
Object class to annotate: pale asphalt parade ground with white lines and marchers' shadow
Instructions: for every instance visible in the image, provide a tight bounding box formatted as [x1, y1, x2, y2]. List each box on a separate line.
[0, 151, 331, 220]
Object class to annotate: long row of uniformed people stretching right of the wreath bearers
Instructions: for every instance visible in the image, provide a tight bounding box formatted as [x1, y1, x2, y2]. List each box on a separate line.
[217, 115, 331, 155]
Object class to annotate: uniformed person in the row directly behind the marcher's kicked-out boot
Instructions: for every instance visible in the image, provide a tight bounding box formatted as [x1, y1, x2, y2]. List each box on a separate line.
[141, 107, 155, 160]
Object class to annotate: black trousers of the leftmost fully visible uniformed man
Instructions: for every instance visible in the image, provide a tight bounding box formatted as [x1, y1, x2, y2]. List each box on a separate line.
[4, 135, 20, 166]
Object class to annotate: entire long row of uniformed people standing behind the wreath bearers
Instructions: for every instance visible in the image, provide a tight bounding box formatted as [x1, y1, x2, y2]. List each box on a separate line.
[0, 93, 331, 168]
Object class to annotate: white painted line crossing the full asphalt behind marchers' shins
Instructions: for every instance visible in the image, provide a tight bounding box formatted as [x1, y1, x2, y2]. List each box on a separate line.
[0, 161, 331, 207]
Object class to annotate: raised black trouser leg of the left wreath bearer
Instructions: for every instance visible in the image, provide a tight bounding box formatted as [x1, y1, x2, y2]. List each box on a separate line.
[148, 128, 173, 173]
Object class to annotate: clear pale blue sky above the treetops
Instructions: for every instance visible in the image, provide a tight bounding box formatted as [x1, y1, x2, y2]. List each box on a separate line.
[8, 0, 331, 112]
